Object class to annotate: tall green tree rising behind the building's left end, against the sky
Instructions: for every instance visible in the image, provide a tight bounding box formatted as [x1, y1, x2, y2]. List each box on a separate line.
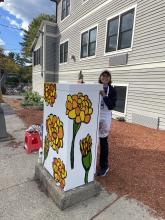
[20, 14, 55, 58]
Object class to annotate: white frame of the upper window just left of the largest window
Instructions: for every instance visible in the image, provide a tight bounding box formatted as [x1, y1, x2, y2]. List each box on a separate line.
[79, 24, 98, 61]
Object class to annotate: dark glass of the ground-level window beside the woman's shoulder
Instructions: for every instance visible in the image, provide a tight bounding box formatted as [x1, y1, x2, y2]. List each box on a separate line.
[114, 85, 127, 114]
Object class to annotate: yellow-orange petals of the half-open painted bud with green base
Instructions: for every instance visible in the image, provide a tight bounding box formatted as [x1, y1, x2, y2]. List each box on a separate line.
[80, 134, 92, 156]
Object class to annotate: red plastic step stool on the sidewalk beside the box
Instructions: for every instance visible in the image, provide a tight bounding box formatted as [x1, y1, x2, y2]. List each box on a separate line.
[25, 131, 42, 154]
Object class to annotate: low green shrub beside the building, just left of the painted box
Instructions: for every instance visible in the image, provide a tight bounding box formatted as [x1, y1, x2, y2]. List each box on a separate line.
[22, 91, 43, 108]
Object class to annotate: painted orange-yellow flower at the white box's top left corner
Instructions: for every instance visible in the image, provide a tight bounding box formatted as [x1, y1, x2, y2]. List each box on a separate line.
[44, 83, 57, 106]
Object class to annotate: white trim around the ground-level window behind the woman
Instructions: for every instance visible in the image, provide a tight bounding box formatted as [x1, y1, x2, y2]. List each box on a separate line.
[112, 83, 129, 117]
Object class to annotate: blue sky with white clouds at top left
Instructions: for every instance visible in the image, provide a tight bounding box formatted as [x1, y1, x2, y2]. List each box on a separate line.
[0, 0, 55, 53]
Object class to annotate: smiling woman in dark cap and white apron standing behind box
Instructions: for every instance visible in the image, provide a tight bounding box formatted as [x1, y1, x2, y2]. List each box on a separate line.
[97, 70, 116, 176]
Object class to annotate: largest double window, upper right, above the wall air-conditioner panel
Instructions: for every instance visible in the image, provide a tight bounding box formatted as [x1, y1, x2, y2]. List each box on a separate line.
[106, 9, 135, 52]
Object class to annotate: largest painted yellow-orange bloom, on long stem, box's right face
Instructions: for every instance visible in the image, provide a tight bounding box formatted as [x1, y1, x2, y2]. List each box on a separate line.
[66, 93, 93, 124]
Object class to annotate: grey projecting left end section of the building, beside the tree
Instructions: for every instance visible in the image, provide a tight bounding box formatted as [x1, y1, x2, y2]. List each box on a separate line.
[32, 21, 59, 96]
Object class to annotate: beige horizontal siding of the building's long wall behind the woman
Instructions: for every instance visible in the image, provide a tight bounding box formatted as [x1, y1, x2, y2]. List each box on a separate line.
[58, 0, 165, 129]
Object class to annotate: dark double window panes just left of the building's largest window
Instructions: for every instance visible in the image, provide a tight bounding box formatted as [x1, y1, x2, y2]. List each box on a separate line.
[81, 27, 97, 58]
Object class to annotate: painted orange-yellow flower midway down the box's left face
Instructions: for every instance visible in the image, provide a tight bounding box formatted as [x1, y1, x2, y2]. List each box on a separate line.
[46, 114, 64, 153]
